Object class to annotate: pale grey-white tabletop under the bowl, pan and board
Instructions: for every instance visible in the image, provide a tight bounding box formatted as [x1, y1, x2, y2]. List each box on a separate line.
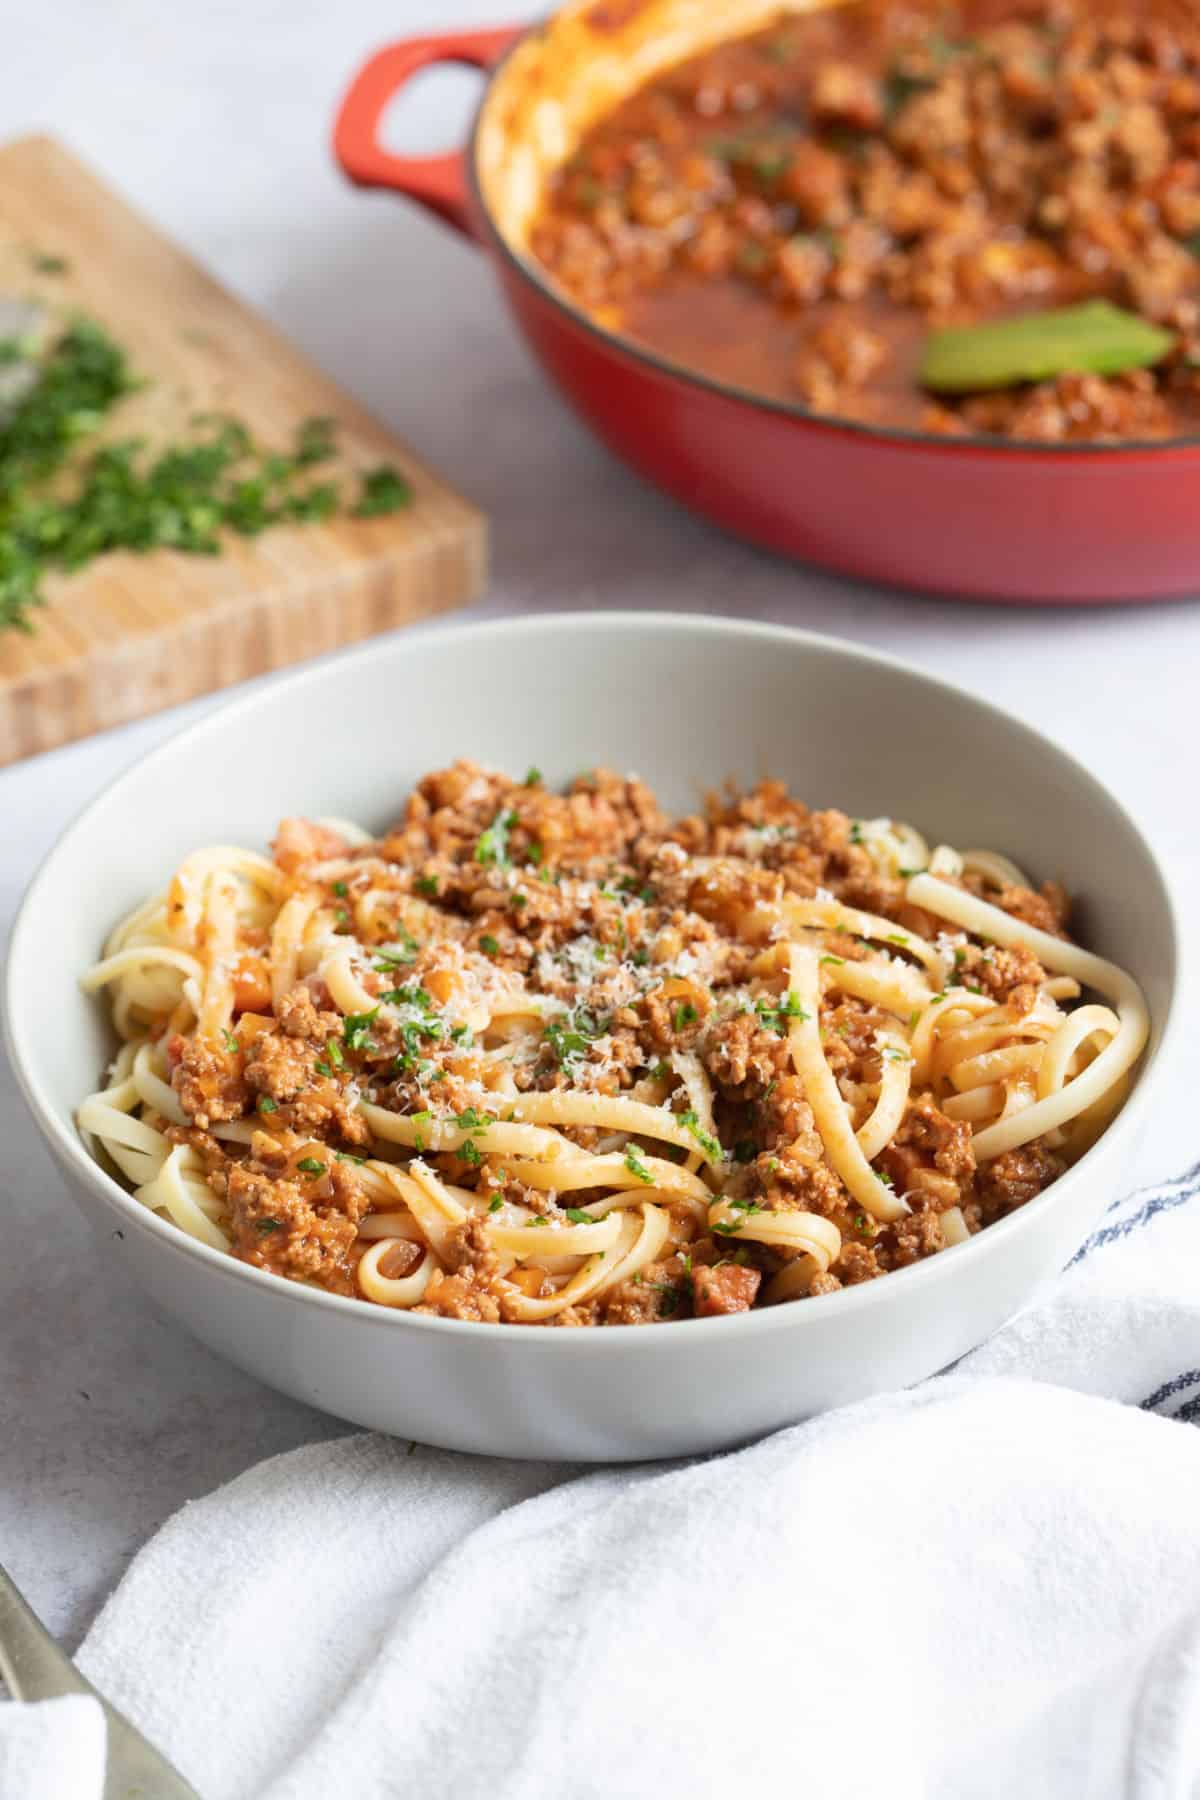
[0, 0, 1200, 1640]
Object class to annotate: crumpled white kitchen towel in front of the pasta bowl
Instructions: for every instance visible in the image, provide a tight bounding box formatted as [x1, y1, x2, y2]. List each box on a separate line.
[4, 1170, 1200, 1800]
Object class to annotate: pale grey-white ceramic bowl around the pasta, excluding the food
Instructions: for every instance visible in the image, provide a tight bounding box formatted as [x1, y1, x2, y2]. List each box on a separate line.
[7, 614, 1177, 1460]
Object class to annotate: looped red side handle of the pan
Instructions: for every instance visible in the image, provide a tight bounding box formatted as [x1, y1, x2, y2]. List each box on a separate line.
[333, 25, 522, 238]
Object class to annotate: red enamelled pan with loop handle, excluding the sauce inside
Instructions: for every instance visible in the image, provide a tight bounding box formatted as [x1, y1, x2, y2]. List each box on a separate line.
[335, 0, 1200, 601]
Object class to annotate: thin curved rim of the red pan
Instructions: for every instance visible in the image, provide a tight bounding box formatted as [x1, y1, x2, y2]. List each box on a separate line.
[462, 0, 1200, 461]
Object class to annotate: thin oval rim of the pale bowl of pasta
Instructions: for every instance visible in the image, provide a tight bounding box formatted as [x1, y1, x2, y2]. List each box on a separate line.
[2, 610, 1184, 1355]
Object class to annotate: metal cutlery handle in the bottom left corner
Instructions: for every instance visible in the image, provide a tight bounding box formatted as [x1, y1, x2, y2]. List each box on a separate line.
[0, 1564, 200, 1800]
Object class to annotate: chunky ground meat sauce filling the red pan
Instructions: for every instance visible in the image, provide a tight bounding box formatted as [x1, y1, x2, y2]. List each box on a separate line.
[531, 0, 1200, 443]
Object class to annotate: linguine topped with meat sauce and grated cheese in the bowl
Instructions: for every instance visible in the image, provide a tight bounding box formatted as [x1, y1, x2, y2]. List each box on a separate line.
[79, 763, 1148, 1325]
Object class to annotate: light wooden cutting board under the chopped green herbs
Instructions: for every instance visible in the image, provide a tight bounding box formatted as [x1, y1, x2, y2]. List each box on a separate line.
[0, 137, 486, 765]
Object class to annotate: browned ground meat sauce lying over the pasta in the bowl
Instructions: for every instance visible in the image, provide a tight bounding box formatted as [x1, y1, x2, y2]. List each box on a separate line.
[126, 766, 1093, 1325]
